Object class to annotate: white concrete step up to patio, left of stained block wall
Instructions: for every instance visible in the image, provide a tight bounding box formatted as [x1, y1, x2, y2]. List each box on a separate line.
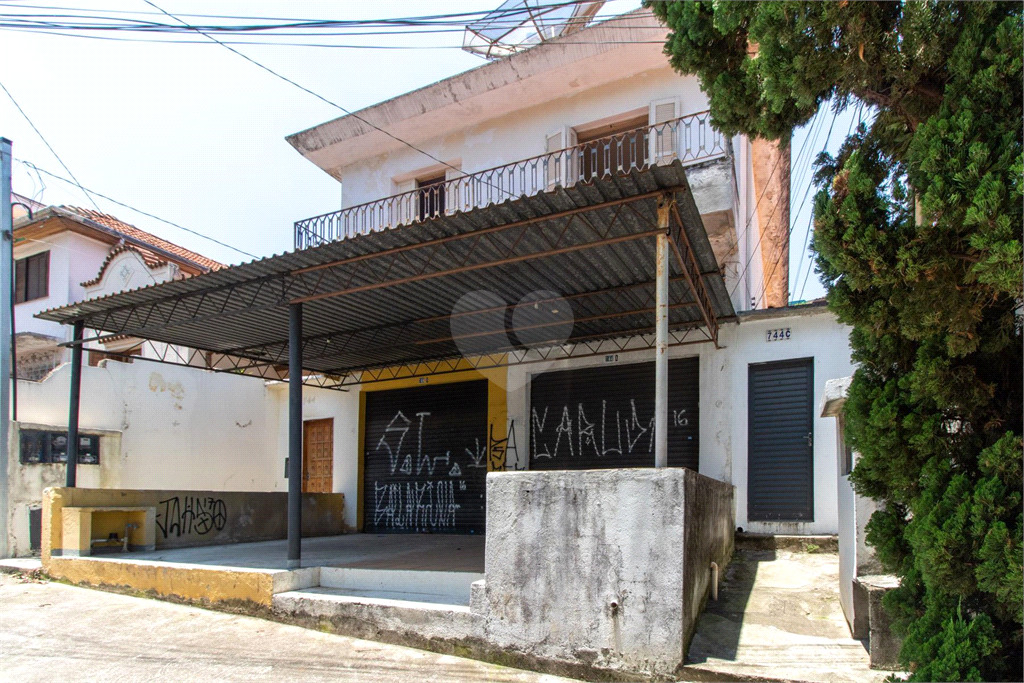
[319, 567, 483, 605]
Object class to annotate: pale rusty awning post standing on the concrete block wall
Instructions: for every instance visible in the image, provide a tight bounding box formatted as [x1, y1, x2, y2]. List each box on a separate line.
[654, 198, 670, 467]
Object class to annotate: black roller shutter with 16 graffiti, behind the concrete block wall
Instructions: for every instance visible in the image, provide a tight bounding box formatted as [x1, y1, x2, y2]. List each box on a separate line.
[528, 357, 700, 470]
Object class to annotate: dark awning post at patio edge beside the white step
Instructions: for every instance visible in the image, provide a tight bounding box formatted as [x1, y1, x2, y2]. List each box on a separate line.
[288, 303, 302, 568]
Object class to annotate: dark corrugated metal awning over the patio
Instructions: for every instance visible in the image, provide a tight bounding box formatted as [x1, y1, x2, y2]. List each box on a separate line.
[39, 162, 734, 382]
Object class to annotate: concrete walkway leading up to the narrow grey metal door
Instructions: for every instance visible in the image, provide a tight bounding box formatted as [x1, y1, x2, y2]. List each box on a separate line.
[681, 550, 889, 683]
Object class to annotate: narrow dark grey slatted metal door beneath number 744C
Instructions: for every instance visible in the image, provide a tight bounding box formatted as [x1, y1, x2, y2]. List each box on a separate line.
[746, 358, 814, 521]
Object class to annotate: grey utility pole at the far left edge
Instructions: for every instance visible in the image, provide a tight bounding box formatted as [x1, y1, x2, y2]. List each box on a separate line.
[0, 137, 14, 557]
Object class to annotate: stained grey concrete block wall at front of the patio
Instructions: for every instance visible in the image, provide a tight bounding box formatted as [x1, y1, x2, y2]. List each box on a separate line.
[474, 469, 734, 675]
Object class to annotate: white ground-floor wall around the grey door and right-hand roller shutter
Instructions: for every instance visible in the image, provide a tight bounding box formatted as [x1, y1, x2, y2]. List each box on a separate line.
[508, 308, 853, 535]
